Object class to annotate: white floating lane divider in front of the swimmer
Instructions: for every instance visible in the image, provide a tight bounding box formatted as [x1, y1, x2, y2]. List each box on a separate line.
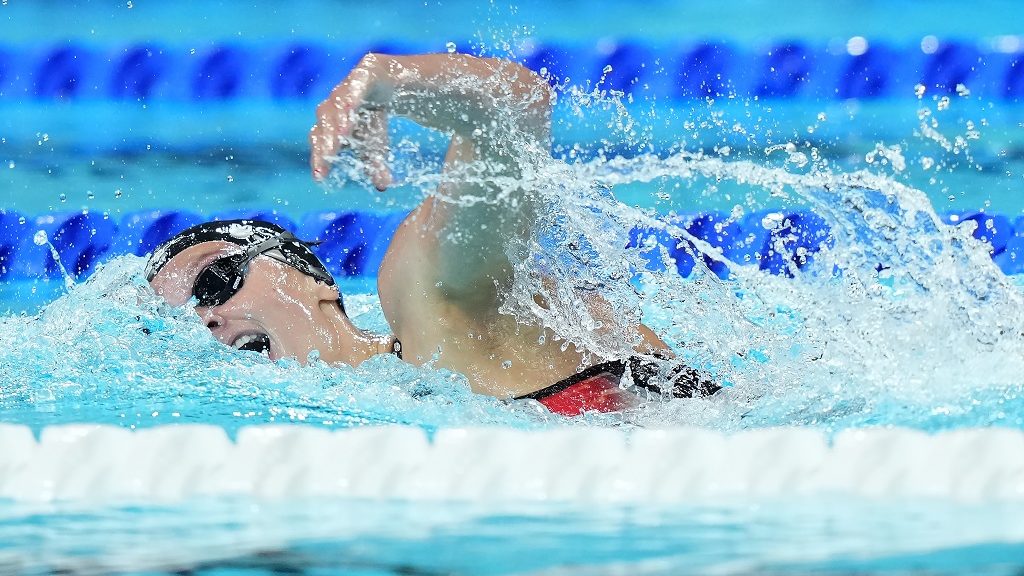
[0, 424, 1024, 503]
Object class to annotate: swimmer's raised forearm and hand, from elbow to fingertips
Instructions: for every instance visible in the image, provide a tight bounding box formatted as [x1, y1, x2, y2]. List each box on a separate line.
[309, 53, 551, 184]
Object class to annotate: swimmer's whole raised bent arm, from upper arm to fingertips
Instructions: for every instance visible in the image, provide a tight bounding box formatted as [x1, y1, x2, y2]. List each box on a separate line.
[309, 53, 552, 307]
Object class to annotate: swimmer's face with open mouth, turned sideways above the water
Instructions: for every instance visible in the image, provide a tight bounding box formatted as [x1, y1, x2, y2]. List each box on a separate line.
[151, 241, 376, 366]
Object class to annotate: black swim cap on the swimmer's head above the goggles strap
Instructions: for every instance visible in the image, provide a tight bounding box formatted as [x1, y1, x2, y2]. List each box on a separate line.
[145, 220, 345, 301]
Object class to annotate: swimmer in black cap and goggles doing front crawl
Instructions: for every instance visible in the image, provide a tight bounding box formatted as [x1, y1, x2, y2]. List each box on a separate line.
[146, 53, 718, 415]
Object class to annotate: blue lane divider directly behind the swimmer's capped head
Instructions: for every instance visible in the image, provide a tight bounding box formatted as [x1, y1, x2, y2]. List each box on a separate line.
[0, 206, 1024, 281]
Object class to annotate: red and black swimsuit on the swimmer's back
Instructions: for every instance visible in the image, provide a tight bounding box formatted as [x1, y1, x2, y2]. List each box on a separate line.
[516, 357, 722, 416]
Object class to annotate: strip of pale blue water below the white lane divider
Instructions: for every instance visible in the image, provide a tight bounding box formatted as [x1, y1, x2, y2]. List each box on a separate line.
[6, 500, 1021, 575]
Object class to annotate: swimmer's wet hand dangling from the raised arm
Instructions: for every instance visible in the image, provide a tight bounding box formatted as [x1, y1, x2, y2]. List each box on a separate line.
[309, 54, 391, 192]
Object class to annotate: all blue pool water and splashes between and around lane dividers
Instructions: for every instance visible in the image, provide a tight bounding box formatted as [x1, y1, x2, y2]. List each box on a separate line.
[6, 1, 1024, 574]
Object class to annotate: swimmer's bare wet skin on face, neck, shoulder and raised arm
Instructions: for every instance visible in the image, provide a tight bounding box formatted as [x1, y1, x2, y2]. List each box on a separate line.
[153, 54, 668, 398]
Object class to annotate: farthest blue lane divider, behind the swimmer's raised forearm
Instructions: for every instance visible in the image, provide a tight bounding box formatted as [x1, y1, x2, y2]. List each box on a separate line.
[0, 37, 1024, 104]
